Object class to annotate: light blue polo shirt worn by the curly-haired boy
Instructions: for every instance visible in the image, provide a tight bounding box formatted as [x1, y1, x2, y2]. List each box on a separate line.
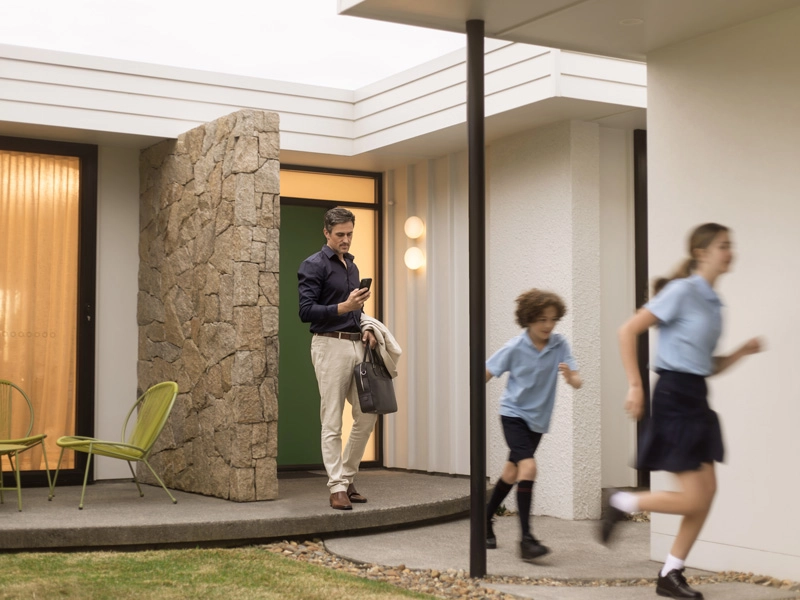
[486, 330, 578, 433]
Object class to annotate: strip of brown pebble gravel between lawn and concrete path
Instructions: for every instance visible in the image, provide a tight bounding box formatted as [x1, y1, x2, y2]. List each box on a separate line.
[261, 539, 800, 600]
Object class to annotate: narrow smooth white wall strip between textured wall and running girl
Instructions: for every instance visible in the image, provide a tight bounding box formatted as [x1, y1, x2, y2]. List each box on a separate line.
[600, 127, 636, 488]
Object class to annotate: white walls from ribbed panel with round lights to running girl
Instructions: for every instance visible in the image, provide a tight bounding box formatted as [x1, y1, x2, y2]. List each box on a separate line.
[385, 122, 644, 518]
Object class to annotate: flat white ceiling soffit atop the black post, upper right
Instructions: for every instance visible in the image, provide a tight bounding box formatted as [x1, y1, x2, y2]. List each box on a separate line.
[339, 0, 800, 60]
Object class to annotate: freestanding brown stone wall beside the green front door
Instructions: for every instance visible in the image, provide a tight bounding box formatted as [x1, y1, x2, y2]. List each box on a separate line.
[138, 110, 280, 501]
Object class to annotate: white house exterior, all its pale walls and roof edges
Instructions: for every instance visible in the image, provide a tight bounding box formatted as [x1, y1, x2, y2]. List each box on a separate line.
[0, 0, 800, 579]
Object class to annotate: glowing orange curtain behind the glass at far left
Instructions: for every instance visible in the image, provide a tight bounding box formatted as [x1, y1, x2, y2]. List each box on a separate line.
[0, 151, 80, 470]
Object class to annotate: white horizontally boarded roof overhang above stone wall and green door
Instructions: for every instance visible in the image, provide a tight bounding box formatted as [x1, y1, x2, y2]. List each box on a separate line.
[0, 40, 646, 171]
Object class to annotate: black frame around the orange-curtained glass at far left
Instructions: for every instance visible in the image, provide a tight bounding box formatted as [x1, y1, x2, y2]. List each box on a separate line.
[0, 136, 97, 487]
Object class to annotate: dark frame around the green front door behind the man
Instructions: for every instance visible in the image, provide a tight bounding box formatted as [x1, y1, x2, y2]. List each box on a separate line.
[278, 163, 384, 472]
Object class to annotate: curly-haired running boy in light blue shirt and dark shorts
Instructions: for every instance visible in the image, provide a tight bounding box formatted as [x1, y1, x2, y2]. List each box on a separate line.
[486, 289, 582, 562]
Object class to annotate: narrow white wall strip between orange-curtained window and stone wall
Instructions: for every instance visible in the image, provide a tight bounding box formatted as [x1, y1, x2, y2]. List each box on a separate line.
[94, 146, 139, 479]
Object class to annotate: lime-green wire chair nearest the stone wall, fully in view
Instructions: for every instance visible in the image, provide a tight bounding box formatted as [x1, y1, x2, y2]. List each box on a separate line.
[53, 381, 178, 510]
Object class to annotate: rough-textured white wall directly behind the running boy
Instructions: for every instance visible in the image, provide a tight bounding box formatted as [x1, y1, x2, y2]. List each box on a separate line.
[487, 122, 600, 519]
